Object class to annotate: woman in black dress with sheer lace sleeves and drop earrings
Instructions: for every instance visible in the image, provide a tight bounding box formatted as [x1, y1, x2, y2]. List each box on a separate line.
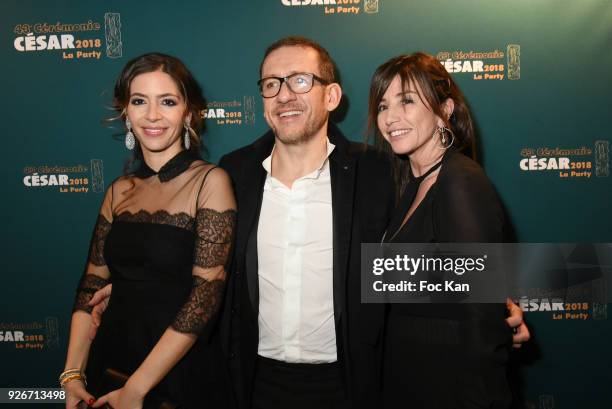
[60, 53, 236, 408]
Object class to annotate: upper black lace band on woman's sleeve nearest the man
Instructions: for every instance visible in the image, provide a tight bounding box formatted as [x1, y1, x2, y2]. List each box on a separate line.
[194, 208, 236, 268]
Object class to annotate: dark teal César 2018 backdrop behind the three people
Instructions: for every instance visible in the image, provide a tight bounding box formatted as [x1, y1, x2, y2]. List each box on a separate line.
[0, 0, 612, 409]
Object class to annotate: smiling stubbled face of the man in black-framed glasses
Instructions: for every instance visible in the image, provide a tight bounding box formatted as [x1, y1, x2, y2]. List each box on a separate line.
[261, 46, 341, 144]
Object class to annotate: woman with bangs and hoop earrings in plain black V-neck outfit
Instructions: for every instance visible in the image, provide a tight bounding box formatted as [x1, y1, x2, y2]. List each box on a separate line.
[369, 53, 512, 409]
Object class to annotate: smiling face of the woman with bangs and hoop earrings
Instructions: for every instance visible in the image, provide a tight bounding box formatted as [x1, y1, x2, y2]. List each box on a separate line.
[377, 75, 443, 155]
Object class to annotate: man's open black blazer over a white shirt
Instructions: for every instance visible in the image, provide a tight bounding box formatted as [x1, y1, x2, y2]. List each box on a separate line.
[219, 124, 394, 409]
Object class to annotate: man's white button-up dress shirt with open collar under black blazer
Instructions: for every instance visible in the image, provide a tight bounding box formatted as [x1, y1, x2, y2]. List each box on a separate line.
[257, 140, 337, 363]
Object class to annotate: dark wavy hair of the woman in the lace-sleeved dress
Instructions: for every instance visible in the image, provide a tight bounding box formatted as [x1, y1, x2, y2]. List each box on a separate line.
[111, 53, 206, 167]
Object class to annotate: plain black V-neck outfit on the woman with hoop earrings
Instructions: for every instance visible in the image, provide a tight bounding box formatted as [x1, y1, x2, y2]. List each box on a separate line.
[383, 150, 511, 409]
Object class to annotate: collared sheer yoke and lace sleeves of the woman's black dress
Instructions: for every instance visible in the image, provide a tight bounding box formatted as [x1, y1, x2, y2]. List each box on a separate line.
[74, 151, 236, 334]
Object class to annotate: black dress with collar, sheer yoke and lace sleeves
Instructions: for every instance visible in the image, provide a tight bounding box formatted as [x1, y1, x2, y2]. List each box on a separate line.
[75, 151, 235, 408]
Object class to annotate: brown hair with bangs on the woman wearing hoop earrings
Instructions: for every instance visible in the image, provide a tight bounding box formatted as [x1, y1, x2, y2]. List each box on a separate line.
[367, 52, 475, 197]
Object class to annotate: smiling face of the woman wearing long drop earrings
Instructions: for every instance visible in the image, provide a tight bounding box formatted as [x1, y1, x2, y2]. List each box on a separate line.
[126, 71, 187, 162]
